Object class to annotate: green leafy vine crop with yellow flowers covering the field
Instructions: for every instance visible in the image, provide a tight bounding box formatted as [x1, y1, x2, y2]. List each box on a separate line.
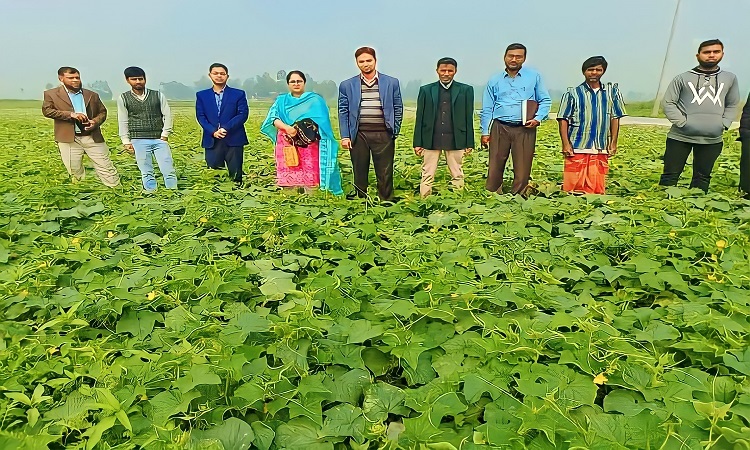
[0, 104, 750, 450]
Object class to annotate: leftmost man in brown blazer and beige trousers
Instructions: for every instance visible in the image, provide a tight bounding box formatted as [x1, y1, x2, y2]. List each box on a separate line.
[42, 67, 120, 187]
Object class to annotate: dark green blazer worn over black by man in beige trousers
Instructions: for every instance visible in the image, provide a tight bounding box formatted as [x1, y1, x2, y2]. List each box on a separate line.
[413, 81, 474, 150]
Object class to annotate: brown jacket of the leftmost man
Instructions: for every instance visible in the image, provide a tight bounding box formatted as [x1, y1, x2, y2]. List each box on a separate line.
[42, 86, 107, 143]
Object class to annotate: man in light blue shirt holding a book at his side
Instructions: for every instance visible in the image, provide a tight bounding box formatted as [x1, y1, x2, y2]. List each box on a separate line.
[479, 44, 552, 195]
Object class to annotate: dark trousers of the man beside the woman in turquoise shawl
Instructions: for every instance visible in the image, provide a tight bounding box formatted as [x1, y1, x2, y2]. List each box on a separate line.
[349, 131, 396, 200]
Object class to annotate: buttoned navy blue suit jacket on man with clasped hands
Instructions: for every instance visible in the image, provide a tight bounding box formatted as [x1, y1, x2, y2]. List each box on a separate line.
[195, 86, 249, 148]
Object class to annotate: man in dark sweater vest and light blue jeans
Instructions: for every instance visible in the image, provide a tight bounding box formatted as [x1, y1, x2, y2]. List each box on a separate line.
[117, 67, 177, 192]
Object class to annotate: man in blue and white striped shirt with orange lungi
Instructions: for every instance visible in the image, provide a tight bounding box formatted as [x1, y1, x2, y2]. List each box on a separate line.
[557, 56, 626, 194]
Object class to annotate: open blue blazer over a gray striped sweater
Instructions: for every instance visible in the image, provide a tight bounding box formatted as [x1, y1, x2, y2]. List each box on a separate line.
[339, 73, 404, 141]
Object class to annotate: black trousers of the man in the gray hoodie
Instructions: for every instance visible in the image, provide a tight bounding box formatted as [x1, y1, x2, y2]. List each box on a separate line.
[659, 138, 724, 192]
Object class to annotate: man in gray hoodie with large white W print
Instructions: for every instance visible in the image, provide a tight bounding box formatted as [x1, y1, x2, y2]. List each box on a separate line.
[659, 39, 740, 192]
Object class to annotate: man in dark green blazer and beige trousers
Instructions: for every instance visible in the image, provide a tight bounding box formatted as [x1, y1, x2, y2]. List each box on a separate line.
[414, 58, 474, 197]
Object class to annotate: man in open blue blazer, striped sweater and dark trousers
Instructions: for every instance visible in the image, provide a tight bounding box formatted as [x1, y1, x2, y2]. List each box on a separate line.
[339, 47, 404, 202]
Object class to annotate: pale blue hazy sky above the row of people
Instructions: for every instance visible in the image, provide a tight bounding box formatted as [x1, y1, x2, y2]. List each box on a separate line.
[0, 0, 750, 98]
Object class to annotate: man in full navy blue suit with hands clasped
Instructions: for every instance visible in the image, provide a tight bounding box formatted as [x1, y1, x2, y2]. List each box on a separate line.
[195, 63, 248, 185]
